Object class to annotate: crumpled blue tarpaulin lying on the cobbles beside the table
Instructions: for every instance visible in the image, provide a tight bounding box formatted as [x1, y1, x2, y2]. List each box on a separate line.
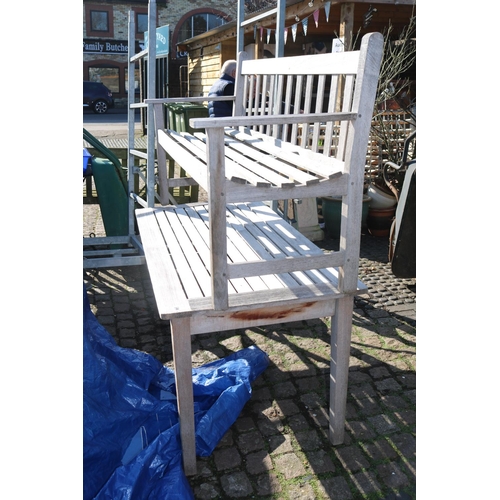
[83, 287, 269, 500]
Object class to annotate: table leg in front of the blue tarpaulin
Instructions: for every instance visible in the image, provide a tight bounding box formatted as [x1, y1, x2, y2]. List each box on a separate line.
[171, 318, 196, 476]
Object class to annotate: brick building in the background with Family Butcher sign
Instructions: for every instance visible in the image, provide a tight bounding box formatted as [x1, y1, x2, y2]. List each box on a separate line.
[83, 0, 237, 107]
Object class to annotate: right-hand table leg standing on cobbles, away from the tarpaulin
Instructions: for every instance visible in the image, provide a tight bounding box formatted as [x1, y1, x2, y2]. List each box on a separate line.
[330, 296, 353, 445]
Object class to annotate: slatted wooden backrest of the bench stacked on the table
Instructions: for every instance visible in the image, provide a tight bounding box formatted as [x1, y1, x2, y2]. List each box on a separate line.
[234, 39, 378, 160]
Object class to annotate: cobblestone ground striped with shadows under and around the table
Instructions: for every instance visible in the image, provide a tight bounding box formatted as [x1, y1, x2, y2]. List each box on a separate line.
[84, 201, 416, 500]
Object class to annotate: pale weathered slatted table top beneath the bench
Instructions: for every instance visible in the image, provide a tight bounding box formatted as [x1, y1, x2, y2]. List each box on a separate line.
[136, 202, 366, 319]
